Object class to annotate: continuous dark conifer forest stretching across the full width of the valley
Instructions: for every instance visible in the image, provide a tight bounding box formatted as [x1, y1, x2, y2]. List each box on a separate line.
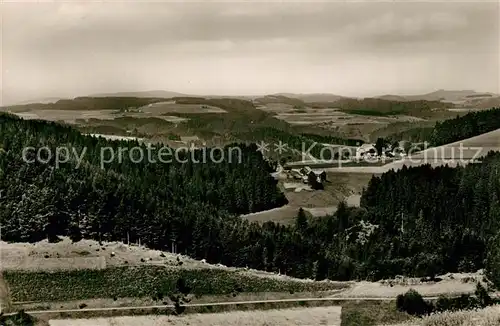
[0, 115, 500, 285]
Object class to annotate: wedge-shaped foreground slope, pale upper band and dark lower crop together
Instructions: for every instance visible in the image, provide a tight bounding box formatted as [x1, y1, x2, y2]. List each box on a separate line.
[0, 238, 348, 308]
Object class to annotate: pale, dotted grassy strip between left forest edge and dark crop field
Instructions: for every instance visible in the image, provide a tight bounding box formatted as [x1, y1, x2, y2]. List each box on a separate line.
[0, 237, 341, 284]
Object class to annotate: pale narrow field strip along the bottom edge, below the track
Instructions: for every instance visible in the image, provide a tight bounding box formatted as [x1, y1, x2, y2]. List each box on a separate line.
[49, 307, 342, 326]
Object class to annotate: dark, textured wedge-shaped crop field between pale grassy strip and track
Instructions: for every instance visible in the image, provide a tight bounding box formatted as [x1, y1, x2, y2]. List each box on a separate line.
[4, 266, 343, 301]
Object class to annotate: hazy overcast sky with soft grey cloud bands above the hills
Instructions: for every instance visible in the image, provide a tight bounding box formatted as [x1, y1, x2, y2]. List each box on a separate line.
[1, 0, 500, 104]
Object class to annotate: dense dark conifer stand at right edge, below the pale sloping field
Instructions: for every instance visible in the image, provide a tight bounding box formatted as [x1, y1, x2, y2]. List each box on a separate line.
[361, 161, 500, 282]
